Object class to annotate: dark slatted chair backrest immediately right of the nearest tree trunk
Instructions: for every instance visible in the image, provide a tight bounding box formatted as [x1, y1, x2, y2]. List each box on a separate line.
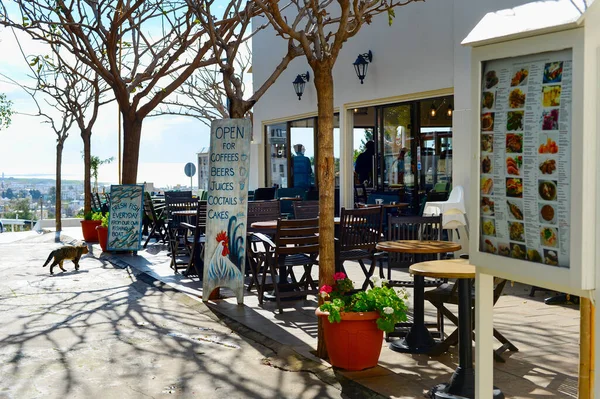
[338, 206, 383, 251]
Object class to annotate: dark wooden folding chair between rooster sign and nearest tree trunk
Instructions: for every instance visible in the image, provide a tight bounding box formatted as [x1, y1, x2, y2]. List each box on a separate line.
[255, 218, 319, 313]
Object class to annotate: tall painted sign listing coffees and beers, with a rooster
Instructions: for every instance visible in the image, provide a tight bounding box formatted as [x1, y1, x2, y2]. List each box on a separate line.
[202, 119, 252, 304]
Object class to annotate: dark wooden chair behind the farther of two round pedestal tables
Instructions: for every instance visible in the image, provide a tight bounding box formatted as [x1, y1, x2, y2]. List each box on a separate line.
[379, 215, 443, 287]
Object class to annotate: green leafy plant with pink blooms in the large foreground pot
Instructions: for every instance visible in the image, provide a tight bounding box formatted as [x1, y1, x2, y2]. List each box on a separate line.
[319, 272, 408, 332]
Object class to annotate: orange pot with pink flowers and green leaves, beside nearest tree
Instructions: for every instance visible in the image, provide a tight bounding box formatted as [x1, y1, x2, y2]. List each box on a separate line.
[315, 273, 407, 370]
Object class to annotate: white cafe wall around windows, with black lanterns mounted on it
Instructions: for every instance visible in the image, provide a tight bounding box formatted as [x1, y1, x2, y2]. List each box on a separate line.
[251, 0, 529, 199]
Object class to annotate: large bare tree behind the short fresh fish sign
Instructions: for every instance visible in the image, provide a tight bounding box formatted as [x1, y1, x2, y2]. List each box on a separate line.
[0, 0, 248, 183]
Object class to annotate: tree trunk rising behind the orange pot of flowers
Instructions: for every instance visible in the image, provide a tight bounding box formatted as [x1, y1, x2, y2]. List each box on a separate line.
[313, 64, 335, 358]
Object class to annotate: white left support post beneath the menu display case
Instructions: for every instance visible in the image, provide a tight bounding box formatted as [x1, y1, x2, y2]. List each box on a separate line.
[475, 270, 494, 399]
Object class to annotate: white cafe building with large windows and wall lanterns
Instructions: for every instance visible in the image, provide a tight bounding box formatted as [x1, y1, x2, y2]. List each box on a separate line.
[250, 0, 591, 209]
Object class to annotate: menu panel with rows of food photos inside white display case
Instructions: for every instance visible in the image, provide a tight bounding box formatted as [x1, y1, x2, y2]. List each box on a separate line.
[479, 50, 573, 268]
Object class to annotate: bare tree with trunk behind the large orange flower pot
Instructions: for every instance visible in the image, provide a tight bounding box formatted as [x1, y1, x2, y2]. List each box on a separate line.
[254, 0, 418, 357]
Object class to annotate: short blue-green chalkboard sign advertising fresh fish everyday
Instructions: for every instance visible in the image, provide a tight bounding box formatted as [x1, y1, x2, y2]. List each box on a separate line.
[107, 184, 144, 251]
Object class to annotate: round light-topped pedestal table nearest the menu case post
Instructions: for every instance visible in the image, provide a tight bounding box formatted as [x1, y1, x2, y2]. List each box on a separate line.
[409, 259, 504, 399]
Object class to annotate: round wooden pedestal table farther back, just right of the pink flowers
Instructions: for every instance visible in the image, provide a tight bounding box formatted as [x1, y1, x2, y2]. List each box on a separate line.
[376, 240, 461, 353]
